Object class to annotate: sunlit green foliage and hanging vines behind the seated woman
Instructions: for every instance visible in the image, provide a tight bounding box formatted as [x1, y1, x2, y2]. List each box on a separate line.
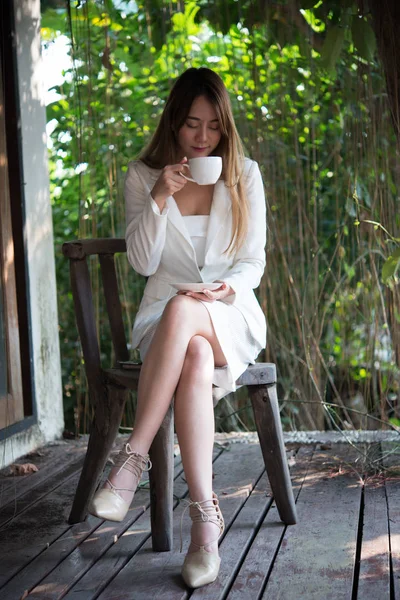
[42, 0, 400, 430]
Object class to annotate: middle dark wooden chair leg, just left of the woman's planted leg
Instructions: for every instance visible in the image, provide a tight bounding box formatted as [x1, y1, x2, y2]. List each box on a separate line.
[149, 405, 174, 552]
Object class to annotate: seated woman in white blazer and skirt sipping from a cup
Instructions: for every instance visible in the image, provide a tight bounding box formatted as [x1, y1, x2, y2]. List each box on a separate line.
[91, 68, 266, 588]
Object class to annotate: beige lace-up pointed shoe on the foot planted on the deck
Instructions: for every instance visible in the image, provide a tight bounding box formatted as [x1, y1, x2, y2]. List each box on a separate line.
[181, 492, 225, 588]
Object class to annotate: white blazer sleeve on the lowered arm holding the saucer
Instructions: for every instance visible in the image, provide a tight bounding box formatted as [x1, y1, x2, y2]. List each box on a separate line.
[222, 161, 267, 304]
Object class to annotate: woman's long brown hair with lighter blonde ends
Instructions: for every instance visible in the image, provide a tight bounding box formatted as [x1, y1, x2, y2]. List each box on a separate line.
[139, 67, 249, 254]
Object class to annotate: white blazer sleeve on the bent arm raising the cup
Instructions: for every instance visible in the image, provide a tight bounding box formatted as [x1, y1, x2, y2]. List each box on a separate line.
[125, 162, 168, 276]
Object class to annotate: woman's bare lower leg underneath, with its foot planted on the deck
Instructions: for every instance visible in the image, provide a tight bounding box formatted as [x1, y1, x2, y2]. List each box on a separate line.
[174, 335, 218, 552]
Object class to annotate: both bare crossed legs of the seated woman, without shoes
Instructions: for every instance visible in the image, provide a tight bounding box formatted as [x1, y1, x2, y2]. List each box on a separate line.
[104, 295, 226, 551]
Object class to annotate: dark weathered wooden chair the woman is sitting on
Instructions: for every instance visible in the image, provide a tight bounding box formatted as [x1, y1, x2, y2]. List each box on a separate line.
[62, 238, 296, 552]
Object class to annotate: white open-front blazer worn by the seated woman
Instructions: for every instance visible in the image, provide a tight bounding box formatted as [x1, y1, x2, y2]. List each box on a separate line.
[125, 159, 266, 352]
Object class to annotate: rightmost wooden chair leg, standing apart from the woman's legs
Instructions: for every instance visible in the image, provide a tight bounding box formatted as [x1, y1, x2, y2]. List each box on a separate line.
[248, 385, 297, 525]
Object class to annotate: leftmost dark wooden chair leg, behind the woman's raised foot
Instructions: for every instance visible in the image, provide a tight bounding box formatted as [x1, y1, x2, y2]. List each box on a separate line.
[68, 385, 129, 525]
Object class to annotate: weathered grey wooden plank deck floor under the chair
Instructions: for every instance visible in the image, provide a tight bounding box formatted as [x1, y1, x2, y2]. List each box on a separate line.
[0, 442, 400, 600]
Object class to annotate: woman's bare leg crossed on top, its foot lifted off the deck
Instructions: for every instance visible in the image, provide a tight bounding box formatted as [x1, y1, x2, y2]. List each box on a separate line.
[103, 296, 226, 502]
